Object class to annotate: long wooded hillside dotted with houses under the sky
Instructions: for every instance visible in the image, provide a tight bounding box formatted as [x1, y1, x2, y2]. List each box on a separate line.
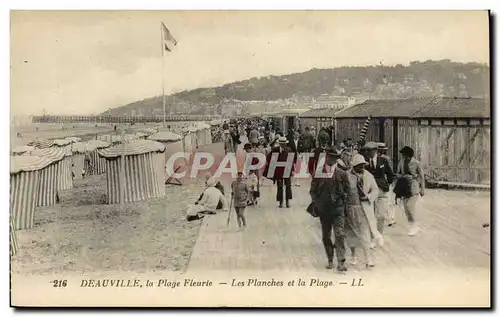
[104, 60, 490, 115]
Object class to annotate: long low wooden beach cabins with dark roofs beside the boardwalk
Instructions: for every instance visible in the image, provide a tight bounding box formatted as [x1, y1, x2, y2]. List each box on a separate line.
[335, 97, 491, 184]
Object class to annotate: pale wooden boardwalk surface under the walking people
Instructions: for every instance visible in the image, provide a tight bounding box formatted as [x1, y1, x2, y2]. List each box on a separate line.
[188, 180, 490, 272]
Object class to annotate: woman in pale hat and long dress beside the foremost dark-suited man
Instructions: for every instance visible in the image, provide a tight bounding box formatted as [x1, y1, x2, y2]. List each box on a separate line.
[345, 154, 379, 268]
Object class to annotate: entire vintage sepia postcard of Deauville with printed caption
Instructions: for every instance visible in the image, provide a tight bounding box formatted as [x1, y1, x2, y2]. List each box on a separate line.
[9, 11, 492, 308]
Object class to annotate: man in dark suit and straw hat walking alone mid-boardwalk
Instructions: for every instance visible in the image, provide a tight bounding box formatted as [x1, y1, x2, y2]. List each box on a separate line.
[264, 136, 295, 208]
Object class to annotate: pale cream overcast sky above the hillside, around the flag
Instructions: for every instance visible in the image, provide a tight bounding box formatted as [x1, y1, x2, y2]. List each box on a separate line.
[11, 11, 489, 115]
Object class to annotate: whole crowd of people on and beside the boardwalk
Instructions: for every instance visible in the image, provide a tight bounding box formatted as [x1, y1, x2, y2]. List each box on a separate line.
[188, 118, 425, 272]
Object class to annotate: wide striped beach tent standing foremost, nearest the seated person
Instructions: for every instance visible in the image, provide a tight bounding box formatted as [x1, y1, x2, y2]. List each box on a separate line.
[98, 140, 165, 204]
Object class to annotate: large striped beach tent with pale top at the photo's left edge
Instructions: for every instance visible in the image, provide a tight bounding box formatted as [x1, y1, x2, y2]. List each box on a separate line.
[10, 156, 53, 230]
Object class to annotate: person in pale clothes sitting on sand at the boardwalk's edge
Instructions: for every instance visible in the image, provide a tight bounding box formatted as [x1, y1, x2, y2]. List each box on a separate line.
[187, 177, 228, 221]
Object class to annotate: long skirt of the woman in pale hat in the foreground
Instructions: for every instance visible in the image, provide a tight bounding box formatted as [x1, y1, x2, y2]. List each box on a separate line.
[345, 205, 371, 249]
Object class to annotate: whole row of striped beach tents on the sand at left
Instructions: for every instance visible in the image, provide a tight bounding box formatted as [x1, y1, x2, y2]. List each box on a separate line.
[10, 123, 216, 254]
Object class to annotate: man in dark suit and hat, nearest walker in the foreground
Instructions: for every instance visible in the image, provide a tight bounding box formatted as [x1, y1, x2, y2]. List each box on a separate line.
[309, 148, 350, 272]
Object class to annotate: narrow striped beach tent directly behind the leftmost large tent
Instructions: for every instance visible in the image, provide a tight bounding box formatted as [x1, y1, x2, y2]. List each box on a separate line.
[31, 148, 64, 207]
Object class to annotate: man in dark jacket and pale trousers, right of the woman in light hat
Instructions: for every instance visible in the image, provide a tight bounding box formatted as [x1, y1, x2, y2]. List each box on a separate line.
[365, 142, 394, 234]
